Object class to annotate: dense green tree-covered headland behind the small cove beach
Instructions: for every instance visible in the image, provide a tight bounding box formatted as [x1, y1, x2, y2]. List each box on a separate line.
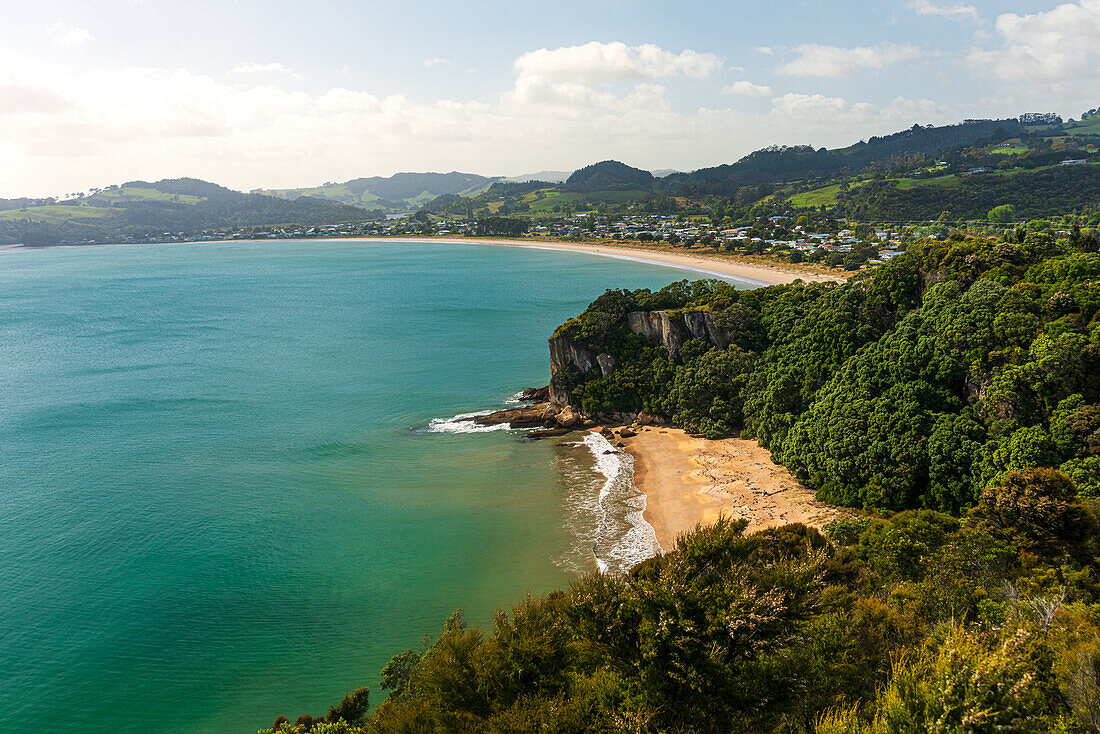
[554, 232, 1100, 511]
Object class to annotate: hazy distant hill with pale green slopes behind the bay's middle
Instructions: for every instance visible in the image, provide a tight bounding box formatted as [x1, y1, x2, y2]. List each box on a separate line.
[253, 171, 499, 210]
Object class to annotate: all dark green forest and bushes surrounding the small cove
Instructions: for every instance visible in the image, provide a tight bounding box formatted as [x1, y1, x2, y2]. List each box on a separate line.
[253, 233, 1100, 734]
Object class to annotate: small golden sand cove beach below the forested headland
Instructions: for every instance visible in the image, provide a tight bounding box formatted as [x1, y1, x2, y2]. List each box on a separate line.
[622, 426, 845, 551]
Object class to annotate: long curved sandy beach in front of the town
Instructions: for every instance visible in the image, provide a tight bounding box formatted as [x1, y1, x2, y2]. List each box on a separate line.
[356, 237, 845, 285]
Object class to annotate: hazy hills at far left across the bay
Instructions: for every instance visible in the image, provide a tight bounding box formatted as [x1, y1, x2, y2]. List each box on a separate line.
[0, 178, 372, 244]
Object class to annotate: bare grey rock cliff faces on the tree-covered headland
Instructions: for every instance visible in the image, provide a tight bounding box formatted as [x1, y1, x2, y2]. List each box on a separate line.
[550, 311, 734, 407]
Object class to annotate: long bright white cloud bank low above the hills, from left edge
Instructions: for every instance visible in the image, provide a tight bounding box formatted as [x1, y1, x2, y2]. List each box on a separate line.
[0, 48, 956, 196]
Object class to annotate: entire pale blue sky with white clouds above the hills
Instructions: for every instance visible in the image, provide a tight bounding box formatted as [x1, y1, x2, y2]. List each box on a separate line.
[0, 0, 1100, 197]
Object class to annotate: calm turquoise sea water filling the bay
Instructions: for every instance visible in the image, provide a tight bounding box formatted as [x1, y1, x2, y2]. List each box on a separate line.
[0, 241, 748, 734]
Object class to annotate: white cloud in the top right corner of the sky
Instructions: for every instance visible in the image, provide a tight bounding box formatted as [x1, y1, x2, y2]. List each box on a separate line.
[968, 0, 1100, 85]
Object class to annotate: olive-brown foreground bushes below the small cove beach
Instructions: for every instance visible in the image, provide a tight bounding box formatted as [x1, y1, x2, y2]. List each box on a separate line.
[259, 506, 1100, 734]
